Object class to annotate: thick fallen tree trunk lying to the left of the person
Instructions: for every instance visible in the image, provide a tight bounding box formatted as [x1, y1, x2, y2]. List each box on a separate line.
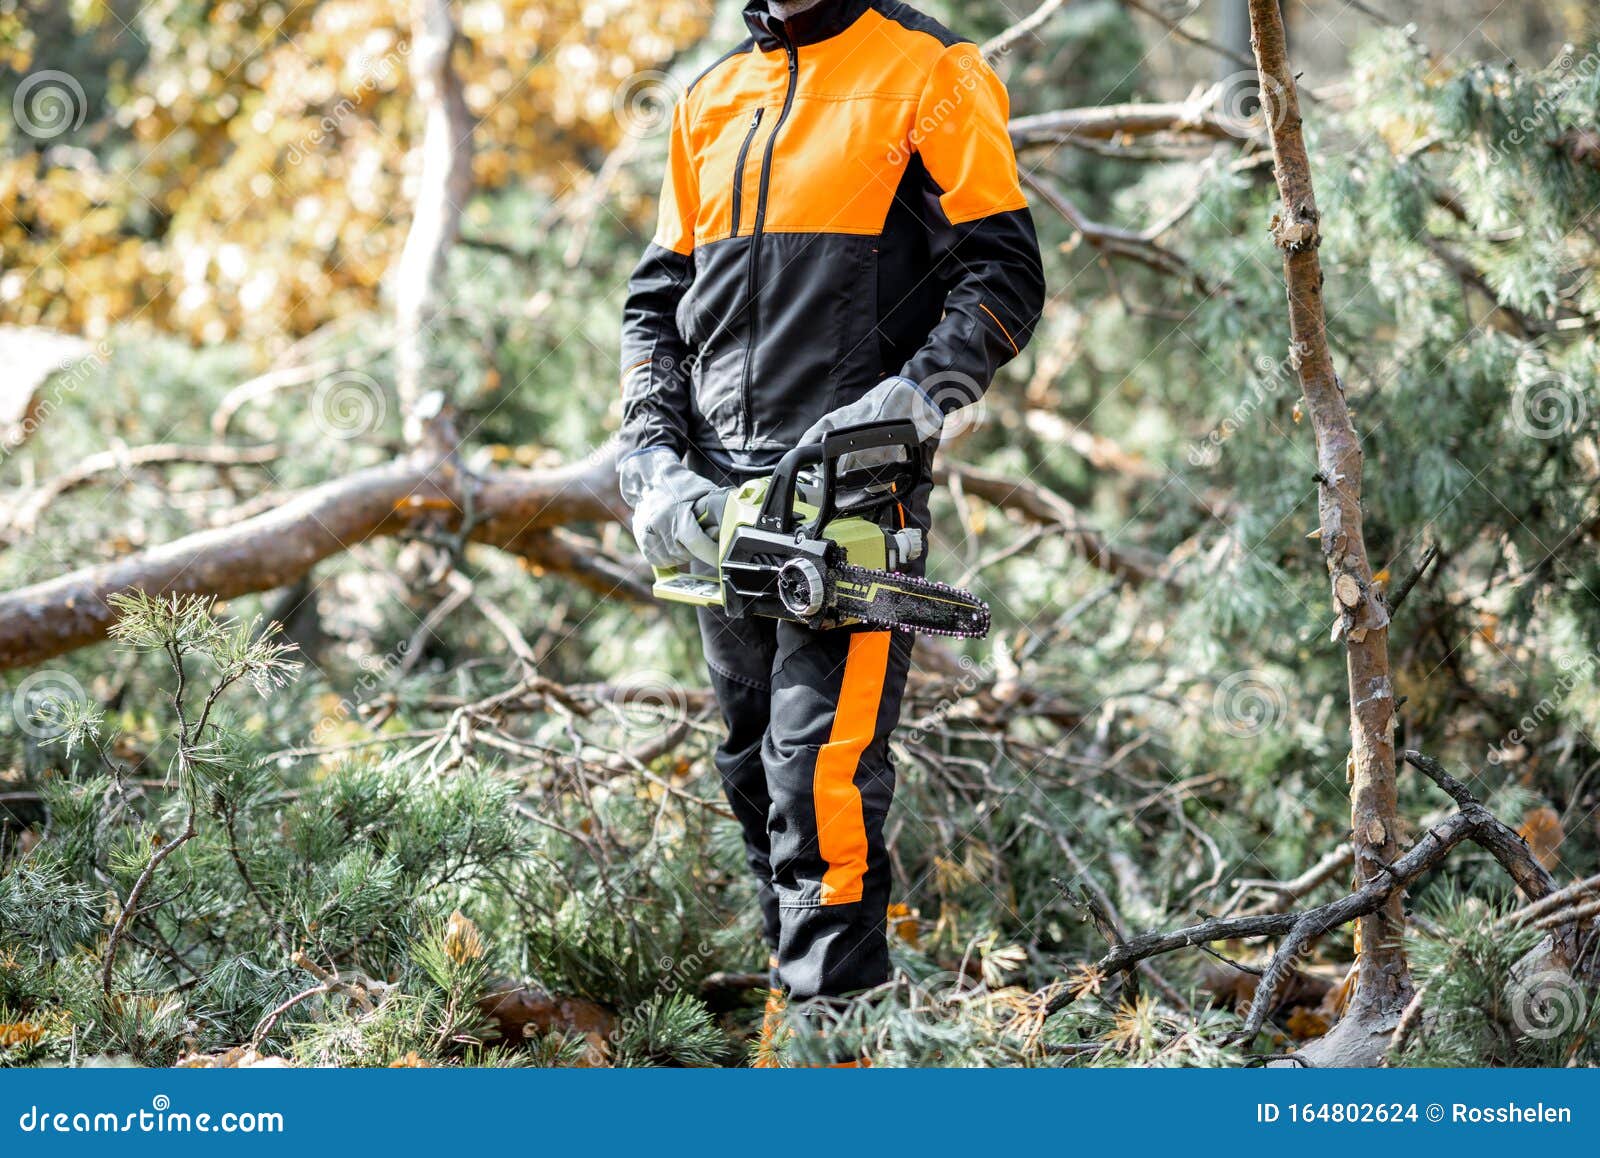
[0, 454, 624, 670]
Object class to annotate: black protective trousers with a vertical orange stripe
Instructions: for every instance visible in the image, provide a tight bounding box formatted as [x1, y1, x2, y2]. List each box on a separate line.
[699, 608, 912, 1001]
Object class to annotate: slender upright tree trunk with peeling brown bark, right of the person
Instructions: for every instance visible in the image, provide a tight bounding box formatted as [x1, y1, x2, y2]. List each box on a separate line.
[1250, 0, 1411, 1028]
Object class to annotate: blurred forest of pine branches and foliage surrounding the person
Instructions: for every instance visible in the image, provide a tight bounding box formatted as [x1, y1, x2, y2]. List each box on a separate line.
[0, 0, 1600, 1065]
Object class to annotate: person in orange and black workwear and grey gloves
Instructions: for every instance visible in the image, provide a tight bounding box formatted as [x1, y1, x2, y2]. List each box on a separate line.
[618, 0, 1043, 1030]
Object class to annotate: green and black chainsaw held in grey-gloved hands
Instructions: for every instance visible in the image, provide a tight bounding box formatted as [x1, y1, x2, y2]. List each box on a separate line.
[653, 422, 989, 638]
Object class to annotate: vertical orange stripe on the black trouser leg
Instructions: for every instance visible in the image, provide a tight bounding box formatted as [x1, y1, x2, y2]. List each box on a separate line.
[811, 632, 891, 905]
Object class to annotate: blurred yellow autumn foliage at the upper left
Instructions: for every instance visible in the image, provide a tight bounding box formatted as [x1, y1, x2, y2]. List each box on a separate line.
[0, 0, 709, 342]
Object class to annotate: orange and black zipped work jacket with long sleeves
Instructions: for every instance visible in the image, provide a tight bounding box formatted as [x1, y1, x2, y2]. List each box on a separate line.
[621, 0, 1043, 469]
